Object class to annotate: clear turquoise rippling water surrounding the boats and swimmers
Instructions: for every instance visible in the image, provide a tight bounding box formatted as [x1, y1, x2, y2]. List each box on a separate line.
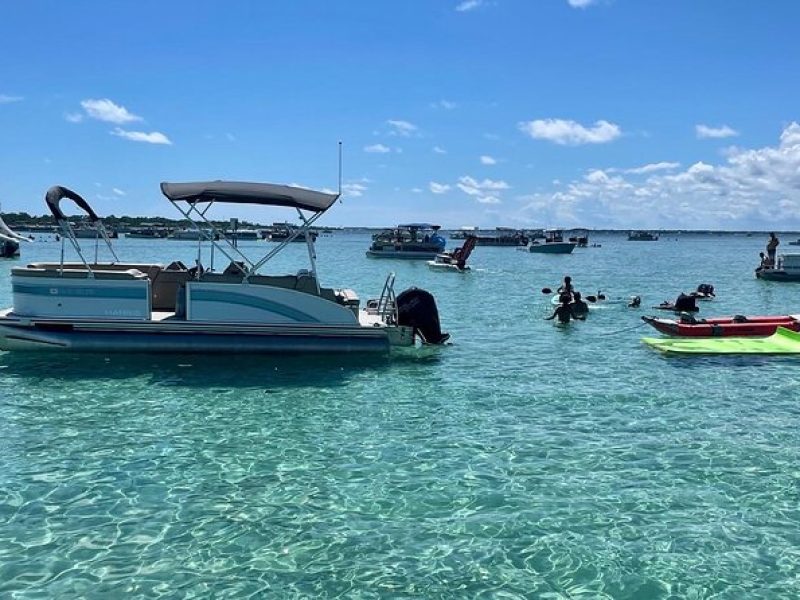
[0, 234, 800, 598]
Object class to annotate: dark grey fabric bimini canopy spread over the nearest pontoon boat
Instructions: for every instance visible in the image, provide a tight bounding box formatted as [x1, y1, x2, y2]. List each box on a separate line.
[161, 181, 339, 212]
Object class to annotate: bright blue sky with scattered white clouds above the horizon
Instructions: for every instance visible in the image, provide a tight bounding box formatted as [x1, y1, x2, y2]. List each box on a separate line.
[0, 0, 800, 228]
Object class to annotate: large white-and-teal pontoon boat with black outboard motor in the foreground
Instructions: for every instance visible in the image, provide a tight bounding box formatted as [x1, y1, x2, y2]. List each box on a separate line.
[0, 181, 449, 353]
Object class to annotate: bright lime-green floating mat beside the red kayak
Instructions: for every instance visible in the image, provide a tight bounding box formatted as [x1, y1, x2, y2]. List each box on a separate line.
[642, 327, 800, 354]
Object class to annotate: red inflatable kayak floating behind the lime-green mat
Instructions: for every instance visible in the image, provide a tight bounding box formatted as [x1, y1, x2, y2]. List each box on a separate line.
[642, 315, 800, 337]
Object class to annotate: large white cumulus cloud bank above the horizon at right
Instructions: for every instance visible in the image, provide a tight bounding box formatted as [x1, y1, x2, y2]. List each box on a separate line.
[523, 123, 800, 229]
